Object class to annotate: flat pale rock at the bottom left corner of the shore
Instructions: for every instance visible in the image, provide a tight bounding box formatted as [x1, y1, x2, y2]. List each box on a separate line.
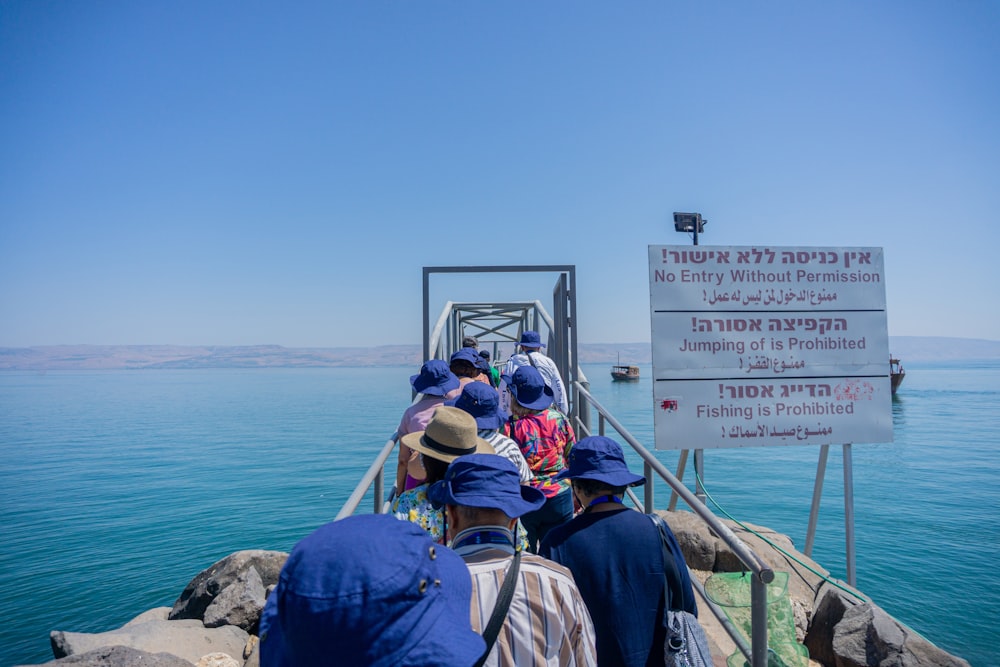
[49, 619, 250, 664]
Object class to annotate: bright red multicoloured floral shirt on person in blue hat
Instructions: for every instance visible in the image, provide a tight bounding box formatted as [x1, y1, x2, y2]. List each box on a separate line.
[502, 408, 576, 498]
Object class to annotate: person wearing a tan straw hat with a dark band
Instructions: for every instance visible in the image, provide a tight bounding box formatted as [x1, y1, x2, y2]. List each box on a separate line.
[392, 405, 493, 544]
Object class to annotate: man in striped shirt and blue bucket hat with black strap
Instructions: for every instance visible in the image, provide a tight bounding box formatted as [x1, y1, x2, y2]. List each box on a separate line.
[428, 454, 597, 667]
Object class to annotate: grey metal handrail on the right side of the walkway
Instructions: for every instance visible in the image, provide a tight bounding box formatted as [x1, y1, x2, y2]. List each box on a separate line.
[575, 382, 774, 667]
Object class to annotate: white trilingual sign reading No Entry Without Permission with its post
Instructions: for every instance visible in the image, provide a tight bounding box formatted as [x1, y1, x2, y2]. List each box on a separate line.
[649, 246, 892, 583]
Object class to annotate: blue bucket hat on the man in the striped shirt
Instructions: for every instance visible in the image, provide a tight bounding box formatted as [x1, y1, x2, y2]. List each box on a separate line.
[427, 454, 545, 519]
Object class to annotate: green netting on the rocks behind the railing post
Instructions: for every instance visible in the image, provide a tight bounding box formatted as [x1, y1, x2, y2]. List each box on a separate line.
[705, 572, 809, 667]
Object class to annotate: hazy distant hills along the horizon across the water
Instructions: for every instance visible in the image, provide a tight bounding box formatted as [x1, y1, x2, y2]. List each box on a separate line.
[0, 336, 1000, 371]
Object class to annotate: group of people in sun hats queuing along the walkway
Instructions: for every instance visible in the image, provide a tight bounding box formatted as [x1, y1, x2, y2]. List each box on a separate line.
[260, 332, 697, 667]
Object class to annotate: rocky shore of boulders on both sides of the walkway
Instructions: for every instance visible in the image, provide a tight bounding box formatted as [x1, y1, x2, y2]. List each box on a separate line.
[22, 512, 969, 667]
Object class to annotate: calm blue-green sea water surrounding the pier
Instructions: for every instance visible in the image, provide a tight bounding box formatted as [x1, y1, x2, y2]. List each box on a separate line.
[0, 361, 1000, 667]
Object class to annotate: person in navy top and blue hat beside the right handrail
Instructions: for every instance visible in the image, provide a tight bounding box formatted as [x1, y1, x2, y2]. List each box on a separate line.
[539, 436, 698, 667]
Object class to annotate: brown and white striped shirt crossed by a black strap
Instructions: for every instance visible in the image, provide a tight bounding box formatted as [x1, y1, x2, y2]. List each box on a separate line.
[455, 531, 597, 667]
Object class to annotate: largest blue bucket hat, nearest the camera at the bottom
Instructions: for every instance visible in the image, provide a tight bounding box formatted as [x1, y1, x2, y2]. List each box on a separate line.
[260, 514, 486, 667]
